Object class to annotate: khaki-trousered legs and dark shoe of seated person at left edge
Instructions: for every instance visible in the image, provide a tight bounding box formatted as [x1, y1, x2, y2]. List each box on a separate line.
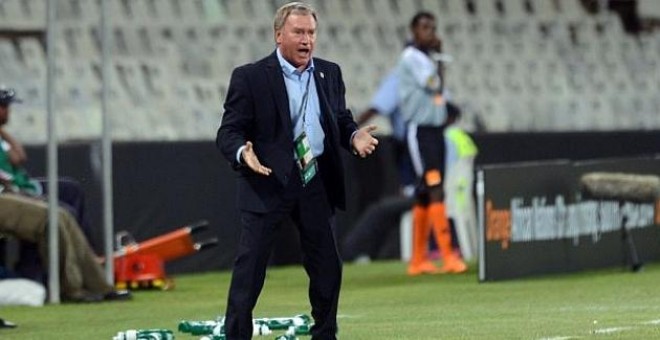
[0, 191, 131, 302]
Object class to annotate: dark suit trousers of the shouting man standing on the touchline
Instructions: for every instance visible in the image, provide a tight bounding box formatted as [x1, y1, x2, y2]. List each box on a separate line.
[225, 165, 342, 340]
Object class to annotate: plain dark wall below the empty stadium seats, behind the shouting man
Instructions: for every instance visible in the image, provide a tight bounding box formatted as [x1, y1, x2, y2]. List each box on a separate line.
[19, 131, 660, 273]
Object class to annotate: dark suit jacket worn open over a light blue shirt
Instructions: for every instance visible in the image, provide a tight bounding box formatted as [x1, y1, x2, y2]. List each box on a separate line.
[216, 52, 357, 212]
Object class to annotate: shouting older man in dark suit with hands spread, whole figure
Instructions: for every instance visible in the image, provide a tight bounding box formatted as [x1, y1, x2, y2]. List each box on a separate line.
[216, 2, 378, 339]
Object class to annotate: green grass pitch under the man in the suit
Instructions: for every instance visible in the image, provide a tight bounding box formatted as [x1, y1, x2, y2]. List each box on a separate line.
[0, 262, 660, 340]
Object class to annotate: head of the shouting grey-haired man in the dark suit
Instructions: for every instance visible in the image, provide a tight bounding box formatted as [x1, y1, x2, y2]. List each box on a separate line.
[275, 13, 316, 70]
